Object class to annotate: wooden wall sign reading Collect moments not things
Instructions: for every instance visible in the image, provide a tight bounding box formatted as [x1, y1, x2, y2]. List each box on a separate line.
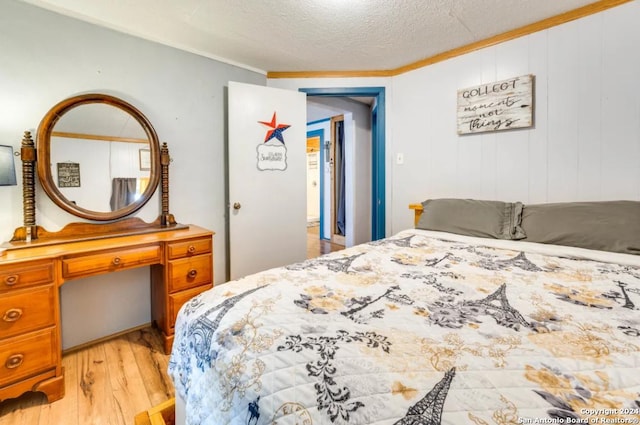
[458, 75, 533, 134]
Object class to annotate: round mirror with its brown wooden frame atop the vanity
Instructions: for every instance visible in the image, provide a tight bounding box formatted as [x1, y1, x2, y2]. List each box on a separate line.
[36, 94, 160, 221]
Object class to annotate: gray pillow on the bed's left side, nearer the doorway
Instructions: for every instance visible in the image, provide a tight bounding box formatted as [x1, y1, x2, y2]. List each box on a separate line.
[416, 199, 526, 239]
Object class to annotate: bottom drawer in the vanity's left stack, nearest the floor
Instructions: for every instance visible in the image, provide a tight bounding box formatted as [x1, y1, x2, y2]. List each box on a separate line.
[0, 327, 59, 387]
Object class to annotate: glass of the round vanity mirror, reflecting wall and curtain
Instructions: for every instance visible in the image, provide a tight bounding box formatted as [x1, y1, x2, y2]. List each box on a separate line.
[50, 103, 151, 212]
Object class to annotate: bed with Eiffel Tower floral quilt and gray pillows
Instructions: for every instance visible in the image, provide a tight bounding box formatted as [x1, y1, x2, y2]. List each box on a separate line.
[169, 201, 640, 425]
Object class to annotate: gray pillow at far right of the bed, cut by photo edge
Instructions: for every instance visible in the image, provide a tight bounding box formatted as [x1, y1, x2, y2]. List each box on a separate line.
[522, 201, 640, 255]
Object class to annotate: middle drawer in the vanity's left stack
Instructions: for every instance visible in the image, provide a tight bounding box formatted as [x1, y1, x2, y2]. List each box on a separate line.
[0, 285, 56, 338]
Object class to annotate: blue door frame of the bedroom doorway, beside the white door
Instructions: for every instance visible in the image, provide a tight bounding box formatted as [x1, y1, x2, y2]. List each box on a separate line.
[298, 87, 386, 240]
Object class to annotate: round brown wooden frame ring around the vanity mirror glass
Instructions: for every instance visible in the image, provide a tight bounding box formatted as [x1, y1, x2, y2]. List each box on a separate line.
[36, 93, 161, 221]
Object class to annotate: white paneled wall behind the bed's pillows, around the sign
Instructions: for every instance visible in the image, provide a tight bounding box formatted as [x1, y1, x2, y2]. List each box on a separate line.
[268, 2, 640, 234]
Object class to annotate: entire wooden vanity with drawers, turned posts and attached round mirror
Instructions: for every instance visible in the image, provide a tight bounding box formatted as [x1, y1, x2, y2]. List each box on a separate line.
[0, 93, 213, 402]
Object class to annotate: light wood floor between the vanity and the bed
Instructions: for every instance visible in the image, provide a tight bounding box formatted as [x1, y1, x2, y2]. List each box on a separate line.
[0, 328, 174, 425]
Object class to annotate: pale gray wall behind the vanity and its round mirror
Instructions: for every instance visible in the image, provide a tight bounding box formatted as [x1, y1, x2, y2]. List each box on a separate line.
[0, 0, 266, 347]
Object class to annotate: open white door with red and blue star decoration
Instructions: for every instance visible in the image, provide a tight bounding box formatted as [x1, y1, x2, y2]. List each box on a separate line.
[228, 81, 307, 279]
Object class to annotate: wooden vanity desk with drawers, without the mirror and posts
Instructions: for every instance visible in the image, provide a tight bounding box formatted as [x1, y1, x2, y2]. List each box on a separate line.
[0, 226, 213, 402]
